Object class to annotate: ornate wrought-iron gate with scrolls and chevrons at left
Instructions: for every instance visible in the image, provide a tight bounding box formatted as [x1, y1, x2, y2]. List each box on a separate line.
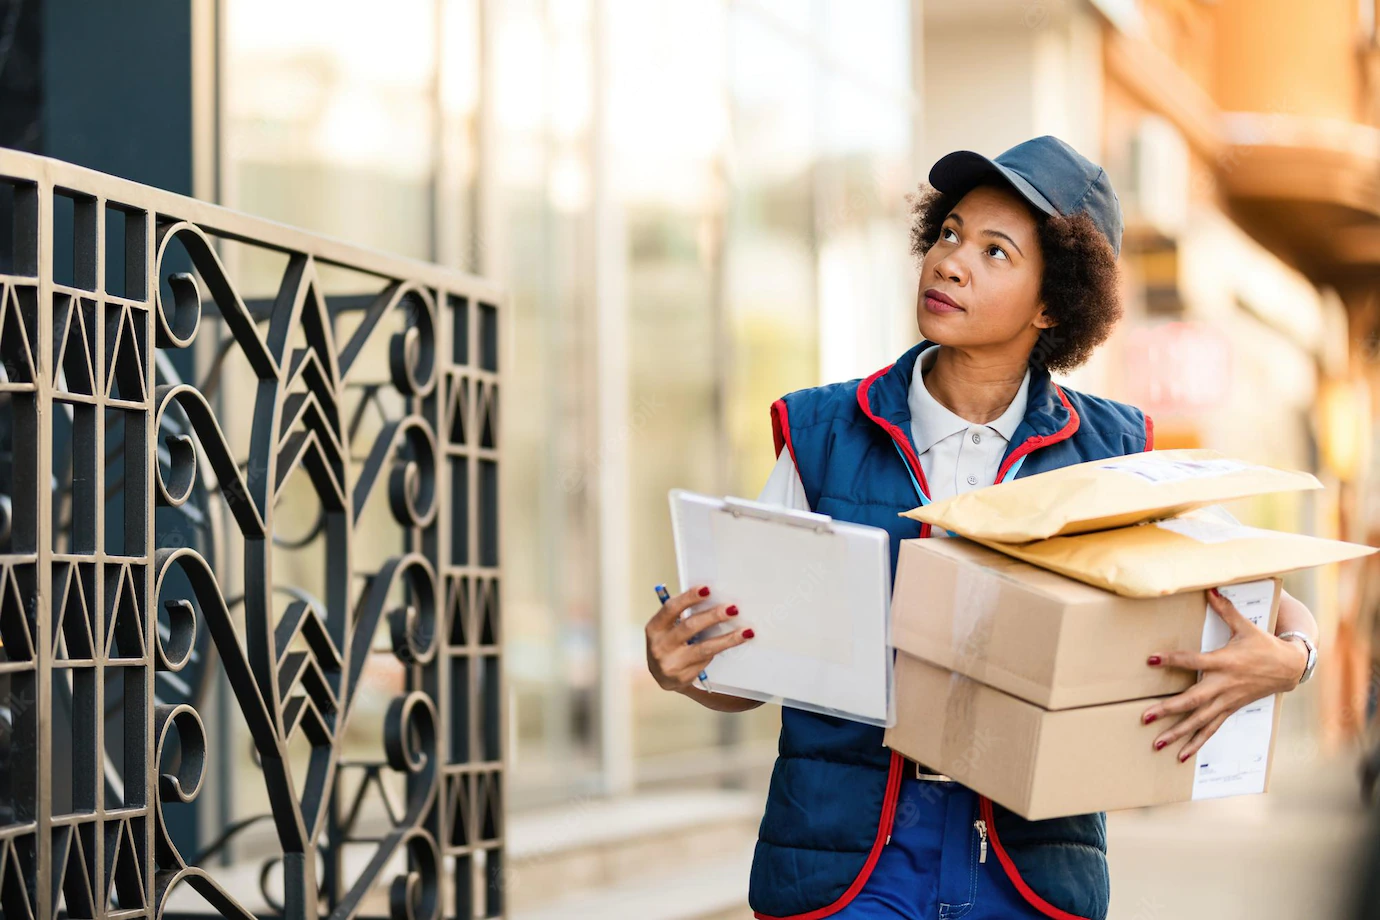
[0, 150, 504, 920]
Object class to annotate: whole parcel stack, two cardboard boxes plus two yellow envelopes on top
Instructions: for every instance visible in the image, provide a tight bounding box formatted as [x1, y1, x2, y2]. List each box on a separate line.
[886, 451, 1374, 819]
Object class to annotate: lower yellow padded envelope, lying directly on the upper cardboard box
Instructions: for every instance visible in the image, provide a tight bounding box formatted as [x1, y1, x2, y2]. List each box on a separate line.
[973, 509, 1376, 597]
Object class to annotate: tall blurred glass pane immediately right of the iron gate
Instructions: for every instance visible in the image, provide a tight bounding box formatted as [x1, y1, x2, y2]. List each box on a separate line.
[494, 0, 599, 801]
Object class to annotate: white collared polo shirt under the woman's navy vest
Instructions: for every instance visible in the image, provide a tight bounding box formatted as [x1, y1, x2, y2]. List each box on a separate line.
[758, 345, 1031, 535]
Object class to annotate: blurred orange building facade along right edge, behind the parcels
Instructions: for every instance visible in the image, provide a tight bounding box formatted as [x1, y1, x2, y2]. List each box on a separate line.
[1103, 0, 1380, 742]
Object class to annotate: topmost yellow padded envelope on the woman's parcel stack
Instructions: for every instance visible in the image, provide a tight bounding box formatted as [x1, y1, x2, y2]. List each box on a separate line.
[903, 450, 1322, 543]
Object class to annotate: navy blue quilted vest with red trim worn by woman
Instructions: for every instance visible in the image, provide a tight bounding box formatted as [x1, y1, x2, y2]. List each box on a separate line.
[748, 341, 1154, 920]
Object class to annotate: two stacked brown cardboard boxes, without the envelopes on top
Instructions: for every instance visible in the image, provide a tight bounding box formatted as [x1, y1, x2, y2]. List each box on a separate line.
[886, 538, 1281, 819]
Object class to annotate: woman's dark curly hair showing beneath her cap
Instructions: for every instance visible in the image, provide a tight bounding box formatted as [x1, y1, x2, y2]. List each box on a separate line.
[907, 183, 1123, 371]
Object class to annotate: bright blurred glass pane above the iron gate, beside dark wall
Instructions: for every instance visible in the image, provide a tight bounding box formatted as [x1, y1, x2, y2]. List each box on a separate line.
[225, 0, 437, 292]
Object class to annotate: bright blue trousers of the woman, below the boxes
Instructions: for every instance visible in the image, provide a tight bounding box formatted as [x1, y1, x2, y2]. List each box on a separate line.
[831, 775, 1043, 920]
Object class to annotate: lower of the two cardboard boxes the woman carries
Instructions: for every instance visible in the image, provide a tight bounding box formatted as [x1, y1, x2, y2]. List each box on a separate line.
[886, 652, 1281, 819]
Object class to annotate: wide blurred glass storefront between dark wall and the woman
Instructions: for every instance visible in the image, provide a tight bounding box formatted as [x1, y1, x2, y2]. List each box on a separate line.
[222, 0, 918, 807]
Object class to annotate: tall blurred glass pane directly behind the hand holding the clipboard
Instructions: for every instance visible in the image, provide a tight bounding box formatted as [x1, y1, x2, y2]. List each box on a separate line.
[609, 0, 727, 759]
